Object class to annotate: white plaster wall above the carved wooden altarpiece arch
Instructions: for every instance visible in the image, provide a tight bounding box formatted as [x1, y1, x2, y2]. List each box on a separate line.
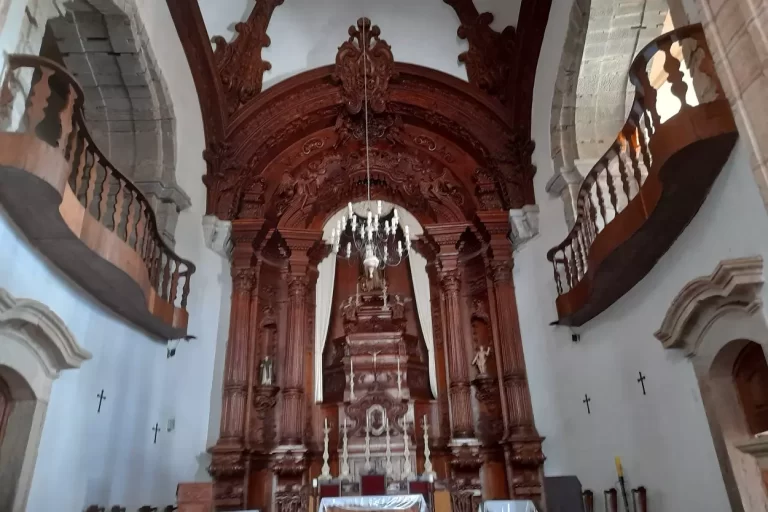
[200, 0, 520, 88]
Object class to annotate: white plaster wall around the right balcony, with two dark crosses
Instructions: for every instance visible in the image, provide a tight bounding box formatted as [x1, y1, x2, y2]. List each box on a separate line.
[514, 0, 768, 512]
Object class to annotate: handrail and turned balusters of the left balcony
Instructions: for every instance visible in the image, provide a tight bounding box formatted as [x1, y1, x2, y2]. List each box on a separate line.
[6, 54, 196, 309]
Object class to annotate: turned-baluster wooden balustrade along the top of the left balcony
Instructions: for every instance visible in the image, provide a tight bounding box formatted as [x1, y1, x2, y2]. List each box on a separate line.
[3, 55, 195, 334]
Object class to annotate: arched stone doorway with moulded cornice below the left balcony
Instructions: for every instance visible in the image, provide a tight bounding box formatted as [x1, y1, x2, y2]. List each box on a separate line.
[0, 288, 91, 512]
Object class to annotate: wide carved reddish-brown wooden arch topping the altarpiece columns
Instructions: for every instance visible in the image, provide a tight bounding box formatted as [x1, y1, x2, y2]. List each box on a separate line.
[205, 52, 534, 227]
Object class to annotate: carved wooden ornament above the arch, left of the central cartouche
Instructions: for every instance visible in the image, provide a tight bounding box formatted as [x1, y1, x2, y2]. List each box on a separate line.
[213, 0, 284, 115]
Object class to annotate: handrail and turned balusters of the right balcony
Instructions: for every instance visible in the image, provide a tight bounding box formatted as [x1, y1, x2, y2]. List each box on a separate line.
[547, 24, 725, 295]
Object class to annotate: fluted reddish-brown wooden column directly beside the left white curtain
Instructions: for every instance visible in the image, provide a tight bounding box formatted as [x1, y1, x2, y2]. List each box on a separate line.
[280, 229, 322, 446]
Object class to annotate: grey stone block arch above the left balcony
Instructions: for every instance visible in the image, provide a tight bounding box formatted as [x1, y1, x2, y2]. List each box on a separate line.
[35, 0, 190, 246]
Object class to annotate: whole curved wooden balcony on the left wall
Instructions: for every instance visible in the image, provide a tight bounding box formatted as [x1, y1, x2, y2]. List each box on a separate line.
[0, 55, 195, 339]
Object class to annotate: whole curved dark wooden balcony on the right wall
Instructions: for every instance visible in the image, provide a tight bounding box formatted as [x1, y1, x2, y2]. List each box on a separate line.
[547, 25, 737, 326]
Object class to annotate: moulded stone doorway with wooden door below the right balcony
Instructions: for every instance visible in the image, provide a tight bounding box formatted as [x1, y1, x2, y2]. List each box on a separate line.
[655, 257, 768, 512]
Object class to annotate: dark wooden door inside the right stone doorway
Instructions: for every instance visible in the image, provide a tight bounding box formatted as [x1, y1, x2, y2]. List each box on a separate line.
[733, 342, 768, 434]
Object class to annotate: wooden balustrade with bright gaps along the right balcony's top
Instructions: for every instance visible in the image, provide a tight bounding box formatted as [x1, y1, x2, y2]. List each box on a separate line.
[547, 25, 725, 308]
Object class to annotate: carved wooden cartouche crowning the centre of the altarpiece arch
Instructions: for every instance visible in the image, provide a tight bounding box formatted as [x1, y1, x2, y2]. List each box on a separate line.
[331, 18, 397, 114]
